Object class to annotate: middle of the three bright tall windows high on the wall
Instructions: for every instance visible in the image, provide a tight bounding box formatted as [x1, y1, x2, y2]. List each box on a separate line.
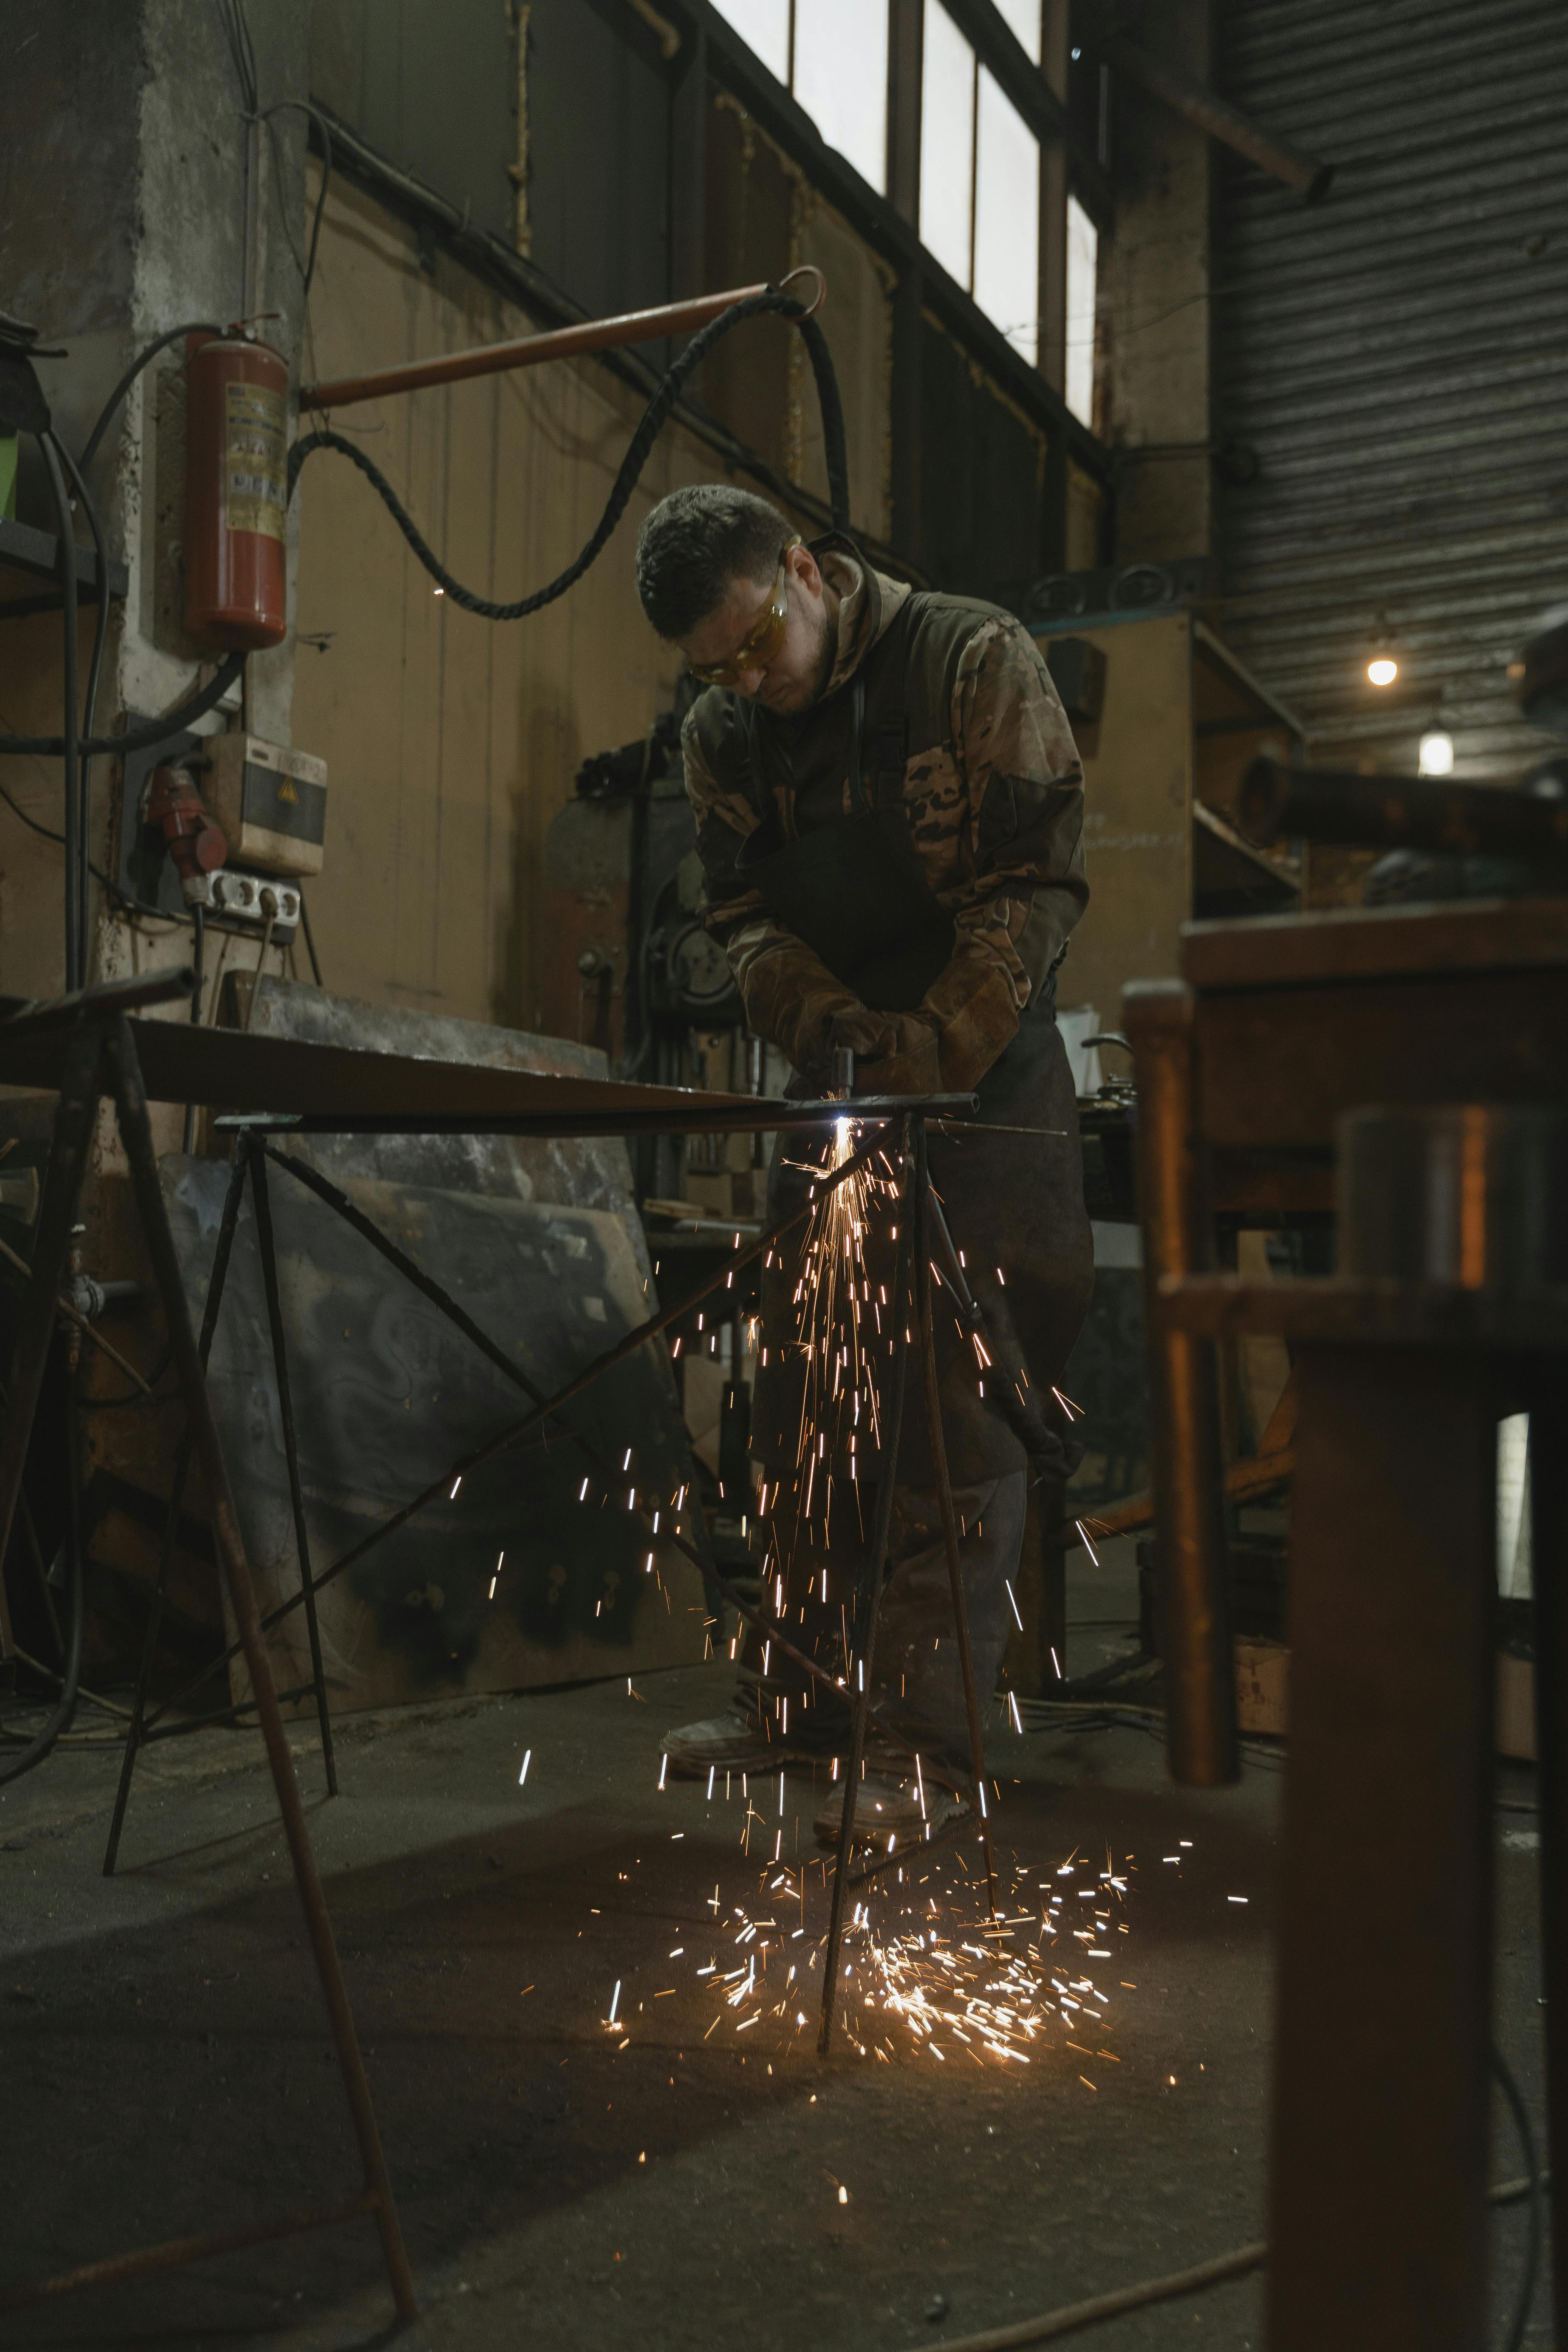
[919, 0, 1039, 365]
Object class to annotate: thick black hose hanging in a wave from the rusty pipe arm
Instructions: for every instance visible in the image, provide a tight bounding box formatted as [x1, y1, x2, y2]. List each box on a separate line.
[289, 287, 849, 621]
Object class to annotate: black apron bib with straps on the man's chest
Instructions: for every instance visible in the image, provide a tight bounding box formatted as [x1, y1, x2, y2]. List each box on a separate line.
[736, 595, 955, 1014]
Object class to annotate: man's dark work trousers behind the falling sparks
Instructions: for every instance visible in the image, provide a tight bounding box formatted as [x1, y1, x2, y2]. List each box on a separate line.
[740, 1002, 1093, 1761]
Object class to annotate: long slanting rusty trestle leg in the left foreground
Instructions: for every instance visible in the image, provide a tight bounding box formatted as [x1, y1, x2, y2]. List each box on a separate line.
[110, 1018, 418, 2319]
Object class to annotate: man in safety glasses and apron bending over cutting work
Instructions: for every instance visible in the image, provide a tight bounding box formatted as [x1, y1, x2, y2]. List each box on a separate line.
[637, 484, 1093, 1837]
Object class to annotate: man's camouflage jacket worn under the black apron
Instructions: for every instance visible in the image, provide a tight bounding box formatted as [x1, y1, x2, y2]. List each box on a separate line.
[682, 550, 1088, 1094]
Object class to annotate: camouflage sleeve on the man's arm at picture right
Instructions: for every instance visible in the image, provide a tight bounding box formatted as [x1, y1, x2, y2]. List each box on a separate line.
[921, 616, 1088, 1089]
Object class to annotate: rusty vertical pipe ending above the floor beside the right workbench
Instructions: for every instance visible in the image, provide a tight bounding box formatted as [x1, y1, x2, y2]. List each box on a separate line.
[1122, 981, 1241, 1787]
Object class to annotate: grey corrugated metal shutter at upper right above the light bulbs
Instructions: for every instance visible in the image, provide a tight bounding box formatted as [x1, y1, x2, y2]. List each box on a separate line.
[1213, 0, 1568, 778]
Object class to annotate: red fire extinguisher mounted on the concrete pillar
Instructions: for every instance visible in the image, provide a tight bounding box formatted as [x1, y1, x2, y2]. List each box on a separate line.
[186, 332, 289, 654]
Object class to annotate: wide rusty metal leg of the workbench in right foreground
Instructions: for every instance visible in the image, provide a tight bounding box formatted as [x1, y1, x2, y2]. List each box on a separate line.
[1267, 1346, 1497, 2352]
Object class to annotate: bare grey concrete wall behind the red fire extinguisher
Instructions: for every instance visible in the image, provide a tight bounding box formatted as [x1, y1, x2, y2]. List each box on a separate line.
[0, 0, 308, 1021]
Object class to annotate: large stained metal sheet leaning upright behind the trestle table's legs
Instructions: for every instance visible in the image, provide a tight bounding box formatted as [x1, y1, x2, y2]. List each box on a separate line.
[162, 1157, 705, 1710]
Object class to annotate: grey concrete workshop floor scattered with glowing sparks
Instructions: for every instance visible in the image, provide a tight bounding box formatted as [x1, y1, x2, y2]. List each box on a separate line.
[0, 1557, 1549, 2352]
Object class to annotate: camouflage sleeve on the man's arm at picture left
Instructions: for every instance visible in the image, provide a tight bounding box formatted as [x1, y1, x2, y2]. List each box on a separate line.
[682, 720, 900, 1082]
